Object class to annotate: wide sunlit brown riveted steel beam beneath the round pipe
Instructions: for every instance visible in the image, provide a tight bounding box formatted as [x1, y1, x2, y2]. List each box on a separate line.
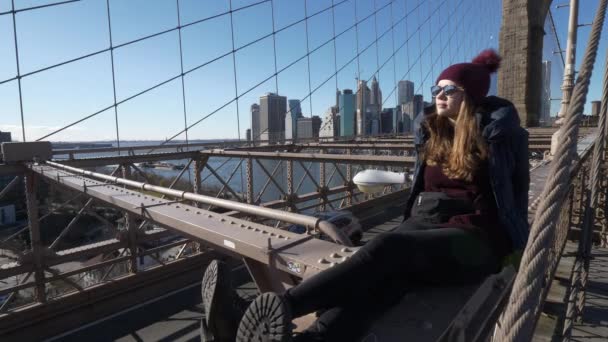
[31, 165, 356, 278]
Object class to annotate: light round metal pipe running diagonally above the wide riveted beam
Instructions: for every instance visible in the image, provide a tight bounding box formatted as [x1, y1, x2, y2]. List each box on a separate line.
[46, 161, 352, 246]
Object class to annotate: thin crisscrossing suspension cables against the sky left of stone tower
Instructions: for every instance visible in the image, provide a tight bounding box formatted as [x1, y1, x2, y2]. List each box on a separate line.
[0, 0, 498, 148]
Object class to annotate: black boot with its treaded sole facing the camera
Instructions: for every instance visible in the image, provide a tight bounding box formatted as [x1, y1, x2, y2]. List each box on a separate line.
[236, 292, 292, 342]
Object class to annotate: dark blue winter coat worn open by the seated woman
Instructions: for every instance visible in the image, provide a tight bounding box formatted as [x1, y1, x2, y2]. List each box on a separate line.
[405, 96, 530, 250]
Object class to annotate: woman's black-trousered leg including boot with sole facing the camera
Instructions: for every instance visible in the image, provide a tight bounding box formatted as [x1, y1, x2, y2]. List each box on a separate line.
[237, 228, 500, 342]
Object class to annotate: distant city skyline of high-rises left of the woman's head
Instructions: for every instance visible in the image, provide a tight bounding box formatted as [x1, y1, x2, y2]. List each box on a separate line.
[247, 77, 425, 143]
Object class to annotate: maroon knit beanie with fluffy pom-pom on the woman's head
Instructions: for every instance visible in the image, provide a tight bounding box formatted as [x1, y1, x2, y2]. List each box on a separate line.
[435, 49, 501, 103]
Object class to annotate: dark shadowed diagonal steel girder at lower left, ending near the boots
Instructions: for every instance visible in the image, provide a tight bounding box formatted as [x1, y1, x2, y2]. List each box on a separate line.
[0, 253, 218, 341]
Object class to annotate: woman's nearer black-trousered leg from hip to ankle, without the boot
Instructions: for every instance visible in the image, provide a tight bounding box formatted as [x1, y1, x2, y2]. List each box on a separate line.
[284, 227, 500, 317]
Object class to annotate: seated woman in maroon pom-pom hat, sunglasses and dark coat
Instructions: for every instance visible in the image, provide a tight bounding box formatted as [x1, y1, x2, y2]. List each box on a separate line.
[237, 50, 529, 341]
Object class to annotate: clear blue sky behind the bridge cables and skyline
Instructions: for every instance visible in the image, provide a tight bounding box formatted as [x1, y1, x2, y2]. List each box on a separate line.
[0, 0, 606, 141]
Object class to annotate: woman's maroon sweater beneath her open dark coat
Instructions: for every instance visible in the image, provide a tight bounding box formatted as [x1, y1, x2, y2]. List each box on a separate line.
[424, 164, 511, 254]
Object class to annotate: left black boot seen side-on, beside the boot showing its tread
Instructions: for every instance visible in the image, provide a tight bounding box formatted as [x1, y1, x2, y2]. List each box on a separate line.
[201, 260, 245, 342]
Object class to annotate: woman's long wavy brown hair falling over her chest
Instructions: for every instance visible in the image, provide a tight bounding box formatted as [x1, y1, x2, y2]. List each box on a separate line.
[423, 93, 488, 181]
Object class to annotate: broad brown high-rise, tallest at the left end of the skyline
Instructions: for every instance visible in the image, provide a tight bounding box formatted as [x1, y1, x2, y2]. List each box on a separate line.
[260, 93, 287, 143]
